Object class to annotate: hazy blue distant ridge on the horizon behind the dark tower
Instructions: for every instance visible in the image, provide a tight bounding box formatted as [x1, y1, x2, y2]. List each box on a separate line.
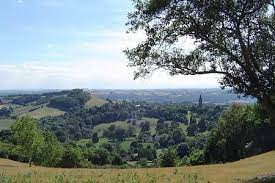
[91, 89, 255, 104]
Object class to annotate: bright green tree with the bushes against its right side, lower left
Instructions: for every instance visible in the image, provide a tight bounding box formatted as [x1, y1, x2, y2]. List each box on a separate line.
[11, 117, 63, 166]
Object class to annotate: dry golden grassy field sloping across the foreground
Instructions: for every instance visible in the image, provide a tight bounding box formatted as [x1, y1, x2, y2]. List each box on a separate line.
[0, 151, 275, 183]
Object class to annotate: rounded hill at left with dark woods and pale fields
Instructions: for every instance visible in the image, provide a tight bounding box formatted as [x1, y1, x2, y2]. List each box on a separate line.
[0, 89, 107, 130]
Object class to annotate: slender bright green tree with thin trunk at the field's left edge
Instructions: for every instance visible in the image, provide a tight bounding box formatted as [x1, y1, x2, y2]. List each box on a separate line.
[11, 116, 43, 166]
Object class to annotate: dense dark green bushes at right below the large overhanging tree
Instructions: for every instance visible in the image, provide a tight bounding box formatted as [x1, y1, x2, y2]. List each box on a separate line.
[205, 105, 275, 163]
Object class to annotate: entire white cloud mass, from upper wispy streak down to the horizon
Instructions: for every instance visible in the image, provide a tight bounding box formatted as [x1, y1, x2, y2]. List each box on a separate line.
[0, 31, 218, 89]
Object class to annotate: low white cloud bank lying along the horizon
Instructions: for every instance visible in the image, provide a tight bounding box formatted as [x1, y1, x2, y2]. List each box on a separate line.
[0, 60, 221, 89]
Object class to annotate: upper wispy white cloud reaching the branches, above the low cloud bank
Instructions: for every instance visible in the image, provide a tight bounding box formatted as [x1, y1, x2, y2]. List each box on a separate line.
[46, 31, 145, 57]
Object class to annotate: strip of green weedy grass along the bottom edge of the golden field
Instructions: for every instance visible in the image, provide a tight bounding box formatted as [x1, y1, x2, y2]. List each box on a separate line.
[0, 171, 208, 183]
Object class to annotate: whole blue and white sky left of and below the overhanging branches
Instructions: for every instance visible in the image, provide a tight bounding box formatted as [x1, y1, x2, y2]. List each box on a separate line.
[0, 0, 219, 90]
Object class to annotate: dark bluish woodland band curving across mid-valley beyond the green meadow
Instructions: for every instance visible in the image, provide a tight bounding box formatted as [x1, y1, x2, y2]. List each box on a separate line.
[40, 101, 223, 142]
